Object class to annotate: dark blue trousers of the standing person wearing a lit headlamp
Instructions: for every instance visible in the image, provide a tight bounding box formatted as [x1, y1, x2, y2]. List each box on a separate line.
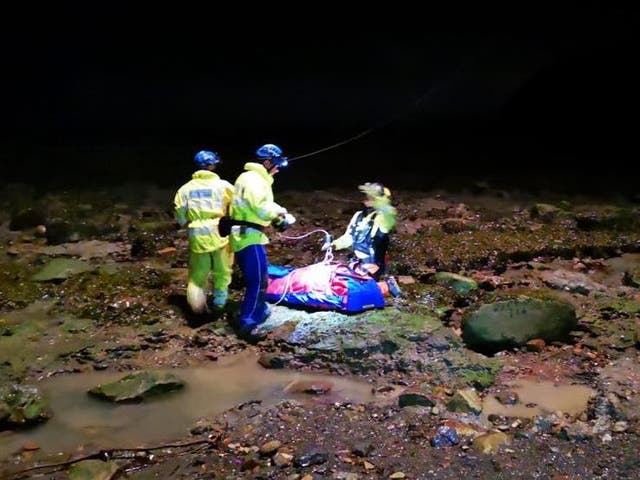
[236, 245, 267, 329]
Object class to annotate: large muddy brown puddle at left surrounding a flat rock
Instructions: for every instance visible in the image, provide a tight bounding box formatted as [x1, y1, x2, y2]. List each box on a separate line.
[0, 355, 373, 458]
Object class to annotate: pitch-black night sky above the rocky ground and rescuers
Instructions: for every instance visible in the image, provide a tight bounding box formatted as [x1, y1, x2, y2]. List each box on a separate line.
[0, 2, 640, 193]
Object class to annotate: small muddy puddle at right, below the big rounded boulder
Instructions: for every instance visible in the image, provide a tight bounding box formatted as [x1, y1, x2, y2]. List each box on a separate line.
[482, 380, 596, 418]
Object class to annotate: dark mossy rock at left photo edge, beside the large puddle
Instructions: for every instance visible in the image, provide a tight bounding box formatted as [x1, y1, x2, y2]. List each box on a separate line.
[0, 384, 51, 430]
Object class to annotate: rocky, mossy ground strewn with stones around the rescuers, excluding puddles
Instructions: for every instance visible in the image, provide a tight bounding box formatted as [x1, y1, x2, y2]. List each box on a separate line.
[0, 185, 640, 480]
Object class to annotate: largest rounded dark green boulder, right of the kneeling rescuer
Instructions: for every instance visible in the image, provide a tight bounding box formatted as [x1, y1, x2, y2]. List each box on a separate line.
[462, 297, 577, 353]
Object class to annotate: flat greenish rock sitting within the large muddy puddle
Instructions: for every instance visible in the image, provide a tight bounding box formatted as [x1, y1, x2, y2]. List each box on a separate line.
[89, 372, 184, 402]
